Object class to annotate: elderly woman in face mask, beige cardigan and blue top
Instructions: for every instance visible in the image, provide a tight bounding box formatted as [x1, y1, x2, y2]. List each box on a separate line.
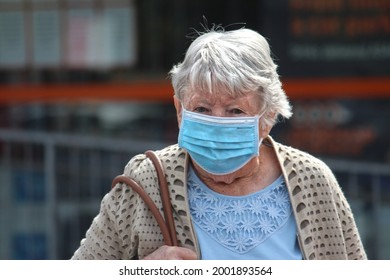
[73, 28, 366, 259]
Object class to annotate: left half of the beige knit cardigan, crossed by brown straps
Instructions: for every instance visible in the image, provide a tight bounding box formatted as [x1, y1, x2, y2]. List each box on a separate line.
[72, 145, 199, 259]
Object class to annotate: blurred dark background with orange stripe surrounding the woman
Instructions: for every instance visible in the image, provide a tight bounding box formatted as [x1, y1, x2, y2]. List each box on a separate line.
[0, 0, 390, 259]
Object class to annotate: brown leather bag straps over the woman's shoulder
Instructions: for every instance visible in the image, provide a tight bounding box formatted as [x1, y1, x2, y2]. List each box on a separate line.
[111, 150, 178, 246]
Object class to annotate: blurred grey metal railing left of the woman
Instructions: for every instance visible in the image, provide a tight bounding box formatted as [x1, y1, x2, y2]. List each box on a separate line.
[0, 129, 166, 259]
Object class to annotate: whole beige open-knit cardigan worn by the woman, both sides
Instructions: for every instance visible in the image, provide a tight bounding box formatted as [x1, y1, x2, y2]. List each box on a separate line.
[72, 137, 367, 260]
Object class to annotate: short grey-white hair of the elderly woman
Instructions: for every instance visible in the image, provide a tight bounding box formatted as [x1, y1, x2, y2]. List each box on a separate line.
[169, 27, 292, 125]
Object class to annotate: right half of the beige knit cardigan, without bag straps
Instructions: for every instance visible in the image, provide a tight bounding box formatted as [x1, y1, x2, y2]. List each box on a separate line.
[273, 142, 367, 259]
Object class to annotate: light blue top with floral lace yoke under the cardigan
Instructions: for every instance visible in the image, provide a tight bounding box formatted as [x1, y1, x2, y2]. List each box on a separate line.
[188, 168, 302, 260]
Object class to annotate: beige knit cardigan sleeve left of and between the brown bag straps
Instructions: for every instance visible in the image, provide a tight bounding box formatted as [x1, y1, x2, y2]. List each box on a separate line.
[72, 155, 164, 260]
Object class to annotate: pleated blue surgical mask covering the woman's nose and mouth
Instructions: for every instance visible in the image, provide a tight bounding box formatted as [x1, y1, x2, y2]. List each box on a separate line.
[178, 109, 261, 175]
